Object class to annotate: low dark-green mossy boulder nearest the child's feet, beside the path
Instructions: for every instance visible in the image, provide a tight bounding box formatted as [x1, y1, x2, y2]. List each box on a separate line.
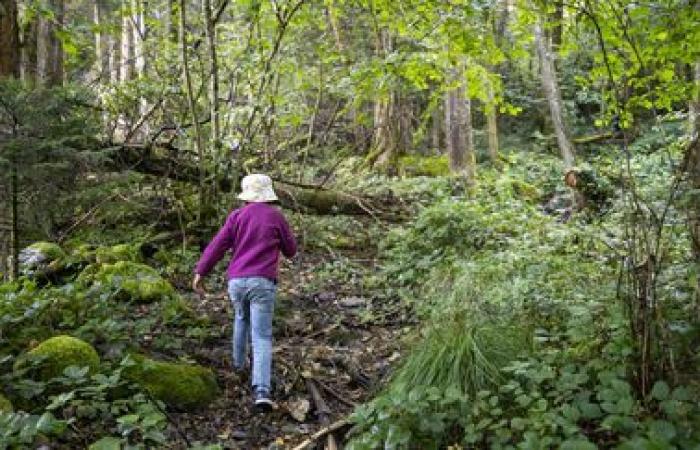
[124, 355, 219, 410]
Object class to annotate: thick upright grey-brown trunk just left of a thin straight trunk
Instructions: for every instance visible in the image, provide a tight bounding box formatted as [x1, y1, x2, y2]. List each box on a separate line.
[445, 63, 475, 183]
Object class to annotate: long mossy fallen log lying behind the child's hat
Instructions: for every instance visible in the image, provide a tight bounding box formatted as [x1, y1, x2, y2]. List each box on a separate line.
[105, 145, 399, 217]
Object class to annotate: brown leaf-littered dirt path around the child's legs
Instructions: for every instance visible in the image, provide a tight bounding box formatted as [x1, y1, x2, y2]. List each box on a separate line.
[161, 218, 412, 449]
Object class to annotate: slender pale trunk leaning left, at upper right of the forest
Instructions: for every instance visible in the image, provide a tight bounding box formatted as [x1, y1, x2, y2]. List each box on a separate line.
[534, 22, 575, 167]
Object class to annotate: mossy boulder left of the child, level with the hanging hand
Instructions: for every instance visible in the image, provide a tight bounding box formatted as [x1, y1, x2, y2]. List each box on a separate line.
[78, 261, 175, 303]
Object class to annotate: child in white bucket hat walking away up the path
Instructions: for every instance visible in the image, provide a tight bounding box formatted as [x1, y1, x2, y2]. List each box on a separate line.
[192, 174, 297, 411]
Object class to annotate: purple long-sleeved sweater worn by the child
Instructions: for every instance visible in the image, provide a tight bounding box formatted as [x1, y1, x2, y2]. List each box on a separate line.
[195, 203, 297, 280]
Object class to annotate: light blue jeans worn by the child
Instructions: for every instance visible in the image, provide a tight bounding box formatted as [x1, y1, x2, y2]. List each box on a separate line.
[228, 277, 277, 391]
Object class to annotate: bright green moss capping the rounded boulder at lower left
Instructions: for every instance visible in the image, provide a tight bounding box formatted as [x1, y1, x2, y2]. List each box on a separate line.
[15, 336, 100, 380]
